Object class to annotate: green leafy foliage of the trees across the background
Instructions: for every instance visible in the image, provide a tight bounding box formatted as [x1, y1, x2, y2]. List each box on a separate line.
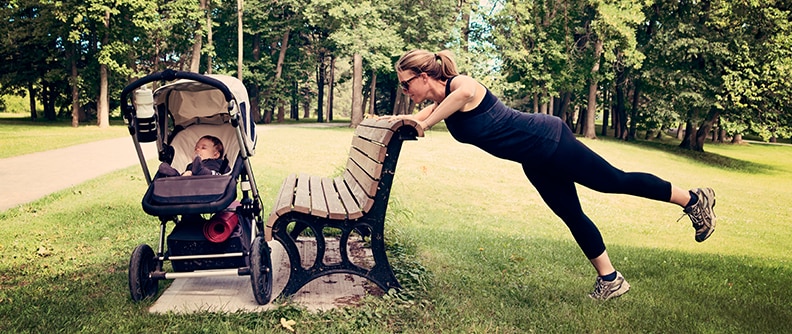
[0, 0, 792, 142]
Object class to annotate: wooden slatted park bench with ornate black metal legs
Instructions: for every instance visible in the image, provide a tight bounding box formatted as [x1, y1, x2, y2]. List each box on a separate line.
[265, 119, 423, 296]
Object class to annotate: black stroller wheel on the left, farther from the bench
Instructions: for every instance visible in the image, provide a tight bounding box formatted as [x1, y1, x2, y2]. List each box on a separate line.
[129, 244, 159, 302]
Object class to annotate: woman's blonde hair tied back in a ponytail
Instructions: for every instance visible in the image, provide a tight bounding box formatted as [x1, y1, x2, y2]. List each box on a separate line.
[396, 50, 459, 90]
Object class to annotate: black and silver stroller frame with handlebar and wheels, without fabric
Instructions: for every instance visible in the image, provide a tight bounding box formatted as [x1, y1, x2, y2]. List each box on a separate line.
[121, 70, 272, 305]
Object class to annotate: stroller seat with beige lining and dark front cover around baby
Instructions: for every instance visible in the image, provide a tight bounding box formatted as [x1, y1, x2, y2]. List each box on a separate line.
[142, 123, 242, 216]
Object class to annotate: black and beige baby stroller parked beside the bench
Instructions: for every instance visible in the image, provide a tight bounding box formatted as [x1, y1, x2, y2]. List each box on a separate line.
[121, 70, 272, 305]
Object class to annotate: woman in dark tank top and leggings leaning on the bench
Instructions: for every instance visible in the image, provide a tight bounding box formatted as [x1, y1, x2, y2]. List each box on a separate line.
[384, 50, 715, 300]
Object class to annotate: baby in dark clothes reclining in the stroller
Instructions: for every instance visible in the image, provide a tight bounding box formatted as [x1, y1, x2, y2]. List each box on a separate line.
[158, 135, 230, 176]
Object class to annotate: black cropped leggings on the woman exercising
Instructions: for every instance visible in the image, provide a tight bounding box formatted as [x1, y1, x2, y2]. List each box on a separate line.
[523, 126, 671, 259]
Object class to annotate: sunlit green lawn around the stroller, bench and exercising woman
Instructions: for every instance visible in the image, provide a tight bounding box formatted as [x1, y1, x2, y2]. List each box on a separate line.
[0, 126, 792, 333]
